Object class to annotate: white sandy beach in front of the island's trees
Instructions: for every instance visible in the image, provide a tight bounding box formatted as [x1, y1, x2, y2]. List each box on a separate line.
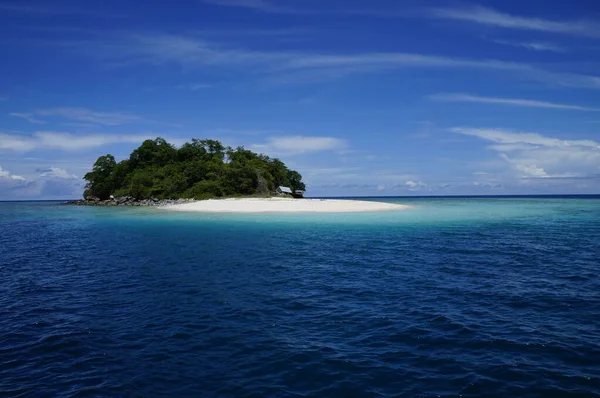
[164, 198, 409, 213]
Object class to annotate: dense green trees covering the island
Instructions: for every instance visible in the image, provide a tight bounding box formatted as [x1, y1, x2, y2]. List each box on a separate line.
[84, 138, 305, 200]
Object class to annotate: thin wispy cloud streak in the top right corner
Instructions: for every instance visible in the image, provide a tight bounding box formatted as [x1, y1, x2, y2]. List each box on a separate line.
[428, 6, 600, 37]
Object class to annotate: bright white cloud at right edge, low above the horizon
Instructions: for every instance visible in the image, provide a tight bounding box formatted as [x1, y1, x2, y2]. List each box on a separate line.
[451, 127, 600, 179]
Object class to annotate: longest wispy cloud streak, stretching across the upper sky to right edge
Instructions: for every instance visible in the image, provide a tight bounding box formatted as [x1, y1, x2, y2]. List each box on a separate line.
[63, 34, 600, 89]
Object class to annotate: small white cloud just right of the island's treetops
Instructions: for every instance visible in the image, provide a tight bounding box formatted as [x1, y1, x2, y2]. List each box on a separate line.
[252, 135, 347, 154]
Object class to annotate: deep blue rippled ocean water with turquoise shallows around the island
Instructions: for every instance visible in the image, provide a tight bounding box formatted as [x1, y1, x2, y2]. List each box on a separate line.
[0, 198, 600, 397]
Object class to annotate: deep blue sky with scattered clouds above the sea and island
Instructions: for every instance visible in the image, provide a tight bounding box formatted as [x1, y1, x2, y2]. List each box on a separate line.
[0, 0, 600, 200]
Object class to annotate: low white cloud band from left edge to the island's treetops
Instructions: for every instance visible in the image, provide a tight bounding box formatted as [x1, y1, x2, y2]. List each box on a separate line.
[0, 131, 156, 152]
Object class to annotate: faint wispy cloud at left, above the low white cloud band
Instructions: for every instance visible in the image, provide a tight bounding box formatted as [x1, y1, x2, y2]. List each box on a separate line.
[10, 108, 145, 126]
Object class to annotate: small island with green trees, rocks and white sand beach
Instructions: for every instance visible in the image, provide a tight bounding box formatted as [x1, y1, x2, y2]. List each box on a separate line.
[69, 137, 406, 212]
